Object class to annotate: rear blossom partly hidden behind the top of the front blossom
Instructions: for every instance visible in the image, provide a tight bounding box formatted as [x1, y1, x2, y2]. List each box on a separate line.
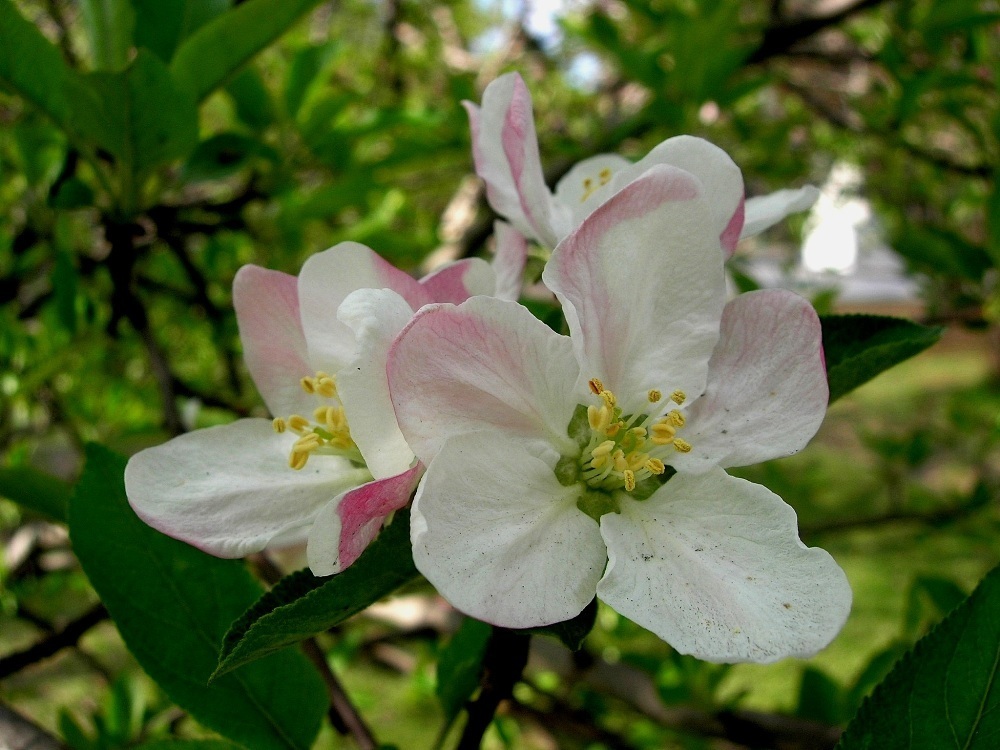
[465, 73, 819, 253]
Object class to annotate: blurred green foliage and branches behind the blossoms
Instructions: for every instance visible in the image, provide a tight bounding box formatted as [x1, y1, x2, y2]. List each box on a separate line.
[0, 0, 1000, 750]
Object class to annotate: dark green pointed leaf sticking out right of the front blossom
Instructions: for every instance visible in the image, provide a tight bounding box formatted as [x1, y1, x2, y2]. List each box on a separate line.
[820, 315, 944, 403]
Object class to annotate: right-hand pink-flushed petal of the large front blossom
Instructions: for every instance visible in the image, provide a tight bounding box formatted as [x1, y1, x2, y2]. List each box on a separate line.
[670, 289, 829, 472]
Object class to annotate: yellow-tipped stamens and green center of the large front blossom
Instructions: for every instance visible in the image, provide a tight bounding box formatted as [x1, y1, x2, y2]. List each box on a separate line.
[579, 378, 691, 492]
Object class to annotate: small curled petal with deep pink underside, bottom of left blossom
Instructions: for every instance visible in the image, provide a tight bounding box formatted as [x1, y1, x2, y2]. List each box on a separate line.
[306, 464, 424, 576]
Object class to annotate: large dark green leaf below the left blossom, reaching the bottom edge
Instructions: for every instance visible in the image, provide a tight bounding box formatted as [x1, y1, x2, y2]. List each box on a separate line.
[69, 445, 327, 750]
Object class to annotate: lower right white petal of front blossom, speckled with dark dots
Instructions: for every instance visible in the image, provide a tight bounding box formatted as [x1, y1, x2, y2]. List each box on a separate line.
[597, 469, 851, 663]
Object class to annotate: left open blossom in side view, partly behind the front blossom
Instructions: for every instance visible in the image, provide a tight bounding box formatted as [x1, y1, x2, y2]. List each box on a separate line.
[125, 242, 516, 575]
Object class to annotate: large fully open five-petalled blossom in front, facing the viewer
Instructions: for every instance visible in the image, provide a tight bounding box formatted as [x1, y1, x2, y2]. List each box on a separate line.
[388, 165, 851, 662]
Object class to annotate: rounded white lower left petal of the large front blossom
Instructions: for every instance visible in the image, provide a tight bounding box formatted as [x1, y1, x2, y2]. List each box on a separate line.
[410, 433, 605, 628]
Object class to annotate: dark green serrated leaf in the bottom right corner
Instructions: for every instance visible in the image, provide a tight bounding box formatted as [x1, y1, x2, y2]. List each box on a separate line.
[837, 567, 1000, 750]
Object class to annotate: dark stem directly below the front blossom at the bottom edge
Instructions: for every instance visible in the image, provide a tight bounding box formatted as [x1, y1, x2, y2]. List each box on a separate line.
[456, 628, 531, 750]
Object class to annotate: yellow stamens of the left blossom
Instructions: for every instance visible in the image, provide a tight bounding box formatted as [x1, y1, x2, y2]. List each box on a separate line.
[272, 372, 365, 471]
